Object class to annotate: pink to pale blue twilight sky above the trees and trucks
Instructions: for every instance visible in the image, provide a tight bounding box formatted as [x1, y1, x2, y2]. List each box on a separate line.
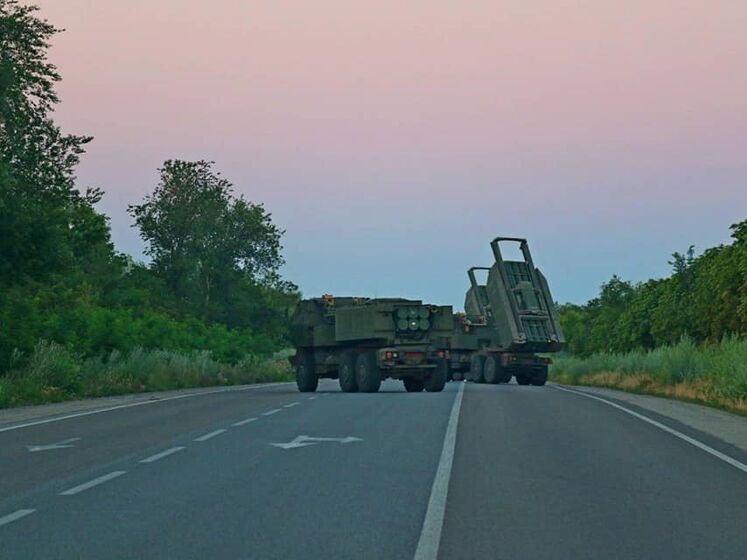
[29, 0, 747, 308]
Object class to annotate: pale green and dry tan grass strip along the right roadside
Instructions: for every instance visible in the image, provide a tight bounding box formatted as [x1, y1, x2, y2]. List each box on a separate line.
[550, 337, 747, 415]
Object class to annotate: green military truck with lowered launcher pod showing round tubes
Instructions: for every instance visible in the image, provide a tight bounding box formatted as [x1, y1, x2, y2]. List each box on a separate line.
[290, 295, 452, 393]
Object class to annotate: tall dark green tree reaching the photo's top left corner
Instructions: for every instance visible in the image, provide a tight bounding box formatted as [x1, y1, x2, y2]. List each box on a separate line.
[0, 0, 113, 282]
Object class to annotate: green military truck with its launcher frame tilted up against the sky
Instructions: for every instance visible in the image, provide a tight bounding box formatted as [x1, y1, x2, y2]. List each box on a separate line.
[448, 237, 564, 385]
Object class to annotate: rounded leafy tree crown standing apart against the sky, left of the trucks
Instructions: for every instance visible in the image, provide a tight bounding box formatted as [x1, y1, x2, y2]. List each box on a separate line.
[129, 160, 287, 318]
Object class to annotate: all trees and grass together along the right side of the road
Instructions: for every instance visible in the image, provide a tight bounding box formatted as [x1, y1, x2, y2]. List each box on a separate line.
[551, 221, 747, 414]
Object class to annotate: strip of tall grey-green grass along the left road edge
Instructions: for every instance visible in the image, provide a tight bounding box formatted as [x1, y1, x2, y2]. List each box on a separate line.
[0, 341, 293, 408]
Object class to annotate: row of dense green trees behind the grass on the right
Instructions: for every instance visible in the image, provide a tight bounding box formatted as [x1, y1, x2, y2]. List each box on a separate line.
[559, 220, 747, 356]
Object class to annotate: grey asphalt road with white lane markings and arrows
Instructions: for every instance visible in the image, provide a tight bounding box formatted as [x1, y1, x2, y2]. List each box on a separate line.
[0, 382, 747, 560]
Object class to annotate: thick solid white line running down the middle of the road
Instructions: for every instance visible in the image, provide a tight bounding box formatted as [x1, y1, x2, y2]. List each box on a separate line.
[415, 383, 465, 560]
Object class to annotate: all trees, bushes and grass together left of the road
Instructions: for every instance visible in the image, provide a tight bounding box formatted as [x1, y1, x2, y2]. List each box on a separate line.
[0, 0, 298, 406]
